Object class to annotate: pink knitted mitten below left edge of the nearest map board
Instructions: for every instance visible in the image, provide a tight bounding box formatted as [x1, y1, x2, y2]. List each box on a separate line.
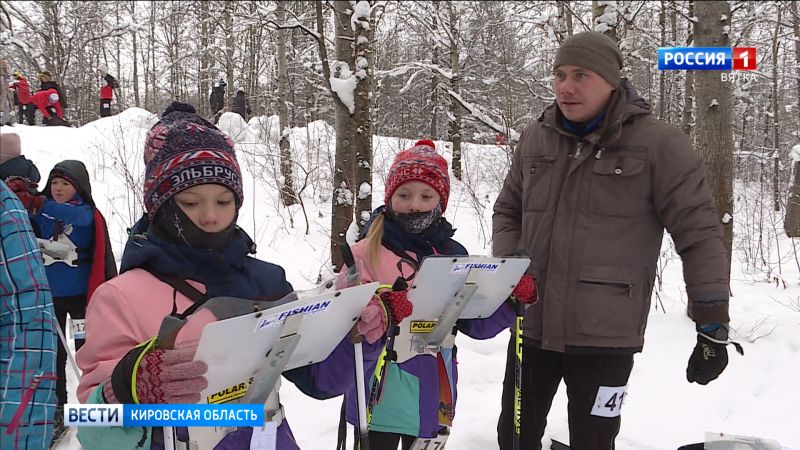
[136, 342, 208, 403]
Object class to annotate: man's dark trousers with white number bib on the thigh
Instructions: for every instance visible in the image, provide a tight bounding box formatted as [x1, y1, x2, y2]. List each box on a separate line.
[498, 345, 633, 450]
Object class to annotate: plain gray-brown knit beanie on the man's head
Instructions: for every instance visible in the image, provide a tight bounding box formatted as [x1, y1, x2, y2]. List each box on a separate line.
[553, 31, 622, 87]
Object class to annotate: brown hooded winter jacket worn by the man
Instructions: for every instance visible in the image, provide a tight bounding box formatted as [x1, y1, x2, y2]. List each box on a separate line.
[493, 80, 729, 352]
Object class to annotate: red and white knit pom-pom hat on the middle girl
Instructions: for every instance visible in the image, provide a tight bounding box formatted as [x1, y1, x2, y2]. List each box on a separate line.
[384, 139, 450, 212]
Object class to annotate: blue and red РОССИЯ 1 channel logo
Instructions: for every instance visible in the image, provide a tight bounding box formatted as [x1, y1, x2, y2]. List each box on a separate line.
[658, 47, 756, 70]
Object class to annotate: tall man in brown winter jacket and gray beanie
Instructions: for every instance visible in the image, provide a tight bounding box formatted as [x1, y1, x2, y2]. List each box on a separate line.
[493, 32, 740, 450]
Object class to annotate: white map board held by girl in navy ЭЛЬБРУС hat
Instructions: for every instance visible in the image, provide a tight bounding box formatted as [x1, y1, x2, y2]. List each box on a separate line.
[194, 282, 378, 403]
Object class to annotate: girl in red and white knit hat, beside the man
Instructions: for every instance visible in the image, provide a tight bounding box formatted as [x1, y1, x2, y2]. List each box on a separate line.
[343, 140, 514, 450]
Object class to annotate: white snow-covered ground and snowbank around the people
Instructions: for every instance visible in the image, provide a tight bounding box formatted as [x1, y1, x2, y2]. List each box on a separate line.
[2, 108, 800, 450]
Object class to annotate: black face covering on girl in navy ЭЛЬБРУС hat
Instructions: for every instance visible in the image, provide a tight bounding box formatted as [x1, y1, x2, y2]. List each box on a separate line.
[150, 198, 239, 252]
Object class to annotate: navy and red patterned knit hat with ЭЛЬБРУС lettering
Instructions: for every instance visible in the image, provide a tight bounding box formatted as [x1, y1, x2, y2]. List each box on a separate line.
[144, 102, 244, 220]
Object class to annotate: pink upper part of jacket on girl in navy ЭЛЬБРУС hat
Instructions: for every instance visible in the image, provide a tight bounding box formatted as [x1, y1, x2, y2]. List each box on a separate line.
[76, 269, 216, 403]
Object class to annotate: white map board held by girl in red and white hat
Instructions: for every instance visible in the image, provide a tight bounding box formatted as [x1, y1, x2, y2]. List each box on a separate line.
[408, 256, 531, 321]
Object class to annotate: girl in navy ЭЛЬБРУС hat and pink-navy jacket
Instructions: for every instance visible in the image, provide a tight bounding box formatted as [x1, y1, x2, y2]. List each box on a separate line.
[77, 102, 382, 450]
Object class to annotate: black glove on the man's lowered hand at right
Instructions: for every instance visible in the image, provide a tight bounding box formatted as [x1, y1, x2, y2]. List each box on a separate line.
[686, 323, 744, 385]
